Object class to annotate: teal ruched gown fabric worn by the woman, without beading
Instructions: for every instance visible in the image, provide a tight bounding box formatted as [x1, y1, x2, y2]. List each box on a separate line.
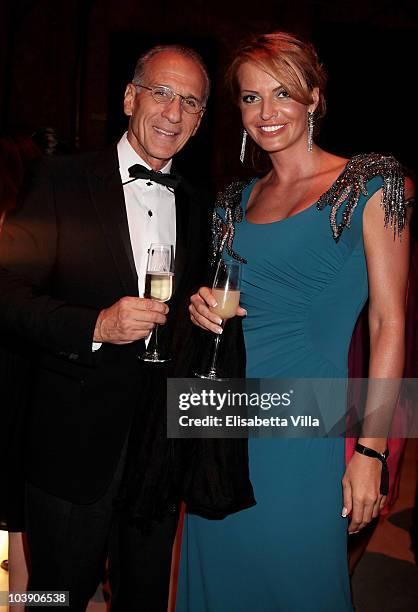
[176, 177, 390, 612]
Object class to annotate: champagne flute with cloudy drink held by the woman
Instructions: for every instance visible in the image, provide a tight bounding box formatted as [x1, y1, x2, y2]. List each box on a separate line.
[196, 259, 242, 380]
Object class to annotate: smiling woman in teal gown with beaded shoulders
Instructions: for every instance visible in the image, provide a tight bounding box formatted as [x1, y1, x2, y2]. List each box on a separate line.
[176, 33, 408, 612]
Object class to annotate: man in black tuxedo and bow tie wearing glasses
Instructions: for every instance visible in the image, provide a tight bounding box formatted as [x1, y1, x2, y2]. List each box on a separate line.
[0, 46, 209, 612]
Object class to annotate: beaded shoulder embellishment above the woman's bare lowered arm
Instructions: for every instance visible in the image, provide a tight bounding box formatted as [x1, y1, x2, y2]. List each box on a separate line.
[316, 153, 408, 242]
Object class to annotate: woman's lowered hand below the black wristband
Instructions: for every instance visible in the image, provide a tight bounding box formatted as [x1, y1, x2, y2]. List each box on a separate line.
[342, 452, 386, 533]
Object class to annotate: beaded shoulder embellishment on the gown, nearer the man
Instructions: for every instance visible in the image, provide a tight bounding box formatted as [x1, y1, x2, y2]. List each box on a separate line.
[212, 181, 249, 263]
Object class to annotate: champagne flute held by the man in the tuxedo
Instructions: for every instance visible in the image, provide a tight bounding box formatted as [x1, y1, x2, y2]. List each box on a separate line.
[139, 243, 174, 363]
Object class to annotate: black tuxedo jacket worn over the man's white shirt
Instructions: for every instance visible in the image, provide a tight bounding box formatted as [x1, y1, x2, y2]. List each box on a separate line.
[0, 147, 208, 503]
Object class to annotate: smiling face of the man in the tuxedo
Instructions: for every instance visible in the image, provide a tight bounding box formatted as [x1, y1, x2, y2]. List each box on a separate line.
[124, 51, 205, 170]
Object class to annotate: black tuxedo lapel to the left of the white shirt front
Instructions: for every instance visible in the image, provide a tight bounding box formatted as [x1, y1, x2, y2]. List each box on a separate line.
[87, 147, 138, 296]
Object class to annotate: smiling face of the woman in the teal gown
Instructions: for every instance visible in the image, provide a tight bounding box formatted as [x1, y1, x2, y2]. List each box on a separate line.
[238, 62, 318, 154]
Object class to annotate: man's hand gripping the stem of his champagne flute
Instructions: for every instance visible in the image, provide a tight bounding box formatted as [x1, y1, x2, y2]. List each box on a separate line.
[93, 297, 168, 344]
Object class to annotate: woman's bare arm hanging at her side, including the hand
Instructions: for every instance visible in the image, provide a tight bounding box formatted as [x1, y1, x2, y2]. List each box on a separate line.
[343, 181, 413, 533]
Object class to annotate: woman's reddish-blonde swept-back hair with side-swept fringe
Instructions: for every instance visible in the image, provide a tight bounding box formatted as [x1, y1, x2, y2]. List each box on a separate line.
[226, 32, 327, 126]
